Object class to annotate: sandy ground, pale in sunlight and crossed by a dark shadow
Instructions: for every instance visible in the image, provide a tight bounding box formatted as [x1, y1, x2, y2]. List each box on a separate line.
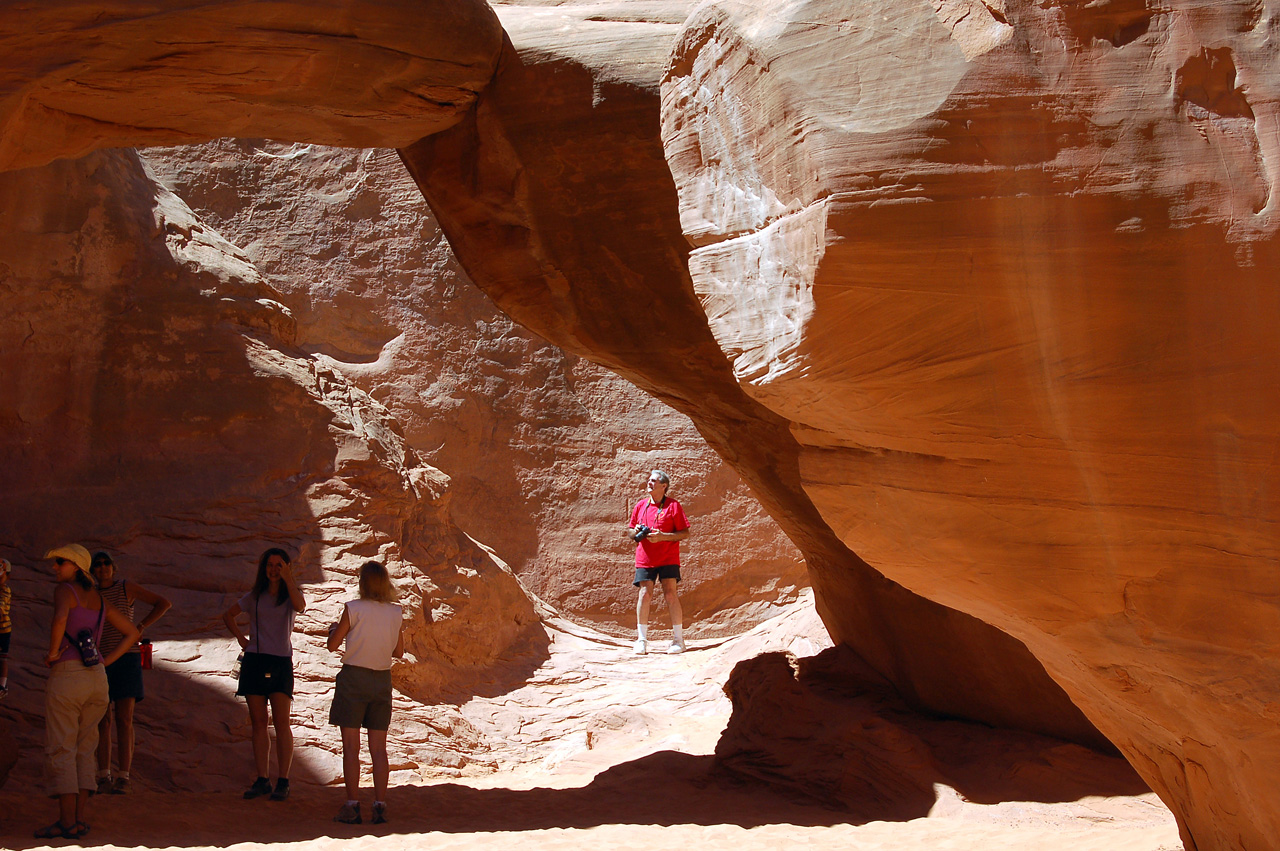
[0, 593, 1181, 851]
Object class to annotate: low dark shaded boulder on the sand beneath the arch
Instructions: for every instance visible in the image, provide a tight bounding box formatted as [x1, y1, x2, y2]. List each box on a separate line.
[716, 646, 1151, 820]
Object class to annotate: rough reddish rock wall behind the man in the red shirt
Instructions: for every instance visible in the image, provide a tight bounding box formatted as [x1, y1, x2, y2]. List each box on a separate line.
[143, 139, 808, 629]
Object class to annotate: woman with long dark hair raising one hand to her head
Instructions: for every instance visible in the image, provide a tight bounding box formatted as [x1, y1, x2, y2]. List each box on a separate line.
[223, 546, 307, 801]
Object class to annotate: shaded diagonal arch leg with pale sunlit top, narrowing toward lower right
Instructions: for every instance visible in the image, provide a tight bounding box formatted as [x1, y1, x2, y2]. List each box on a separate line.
[402, 3, 1106, 746]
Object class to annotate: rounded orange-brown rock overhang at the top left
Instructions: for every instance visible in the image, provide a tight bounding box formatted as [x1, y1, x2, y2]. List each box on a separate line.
[0, 0, 502, 170]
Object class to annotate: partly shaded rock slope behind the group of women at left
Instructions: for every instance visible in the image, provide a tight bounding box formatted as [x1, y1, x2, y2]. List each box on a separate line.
[0, 151, 548, 790]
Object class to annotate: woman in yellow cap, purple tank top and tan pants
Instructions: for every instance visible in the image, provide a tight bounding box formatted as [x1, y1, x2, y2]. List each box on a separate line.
[36, 544, 138, 839]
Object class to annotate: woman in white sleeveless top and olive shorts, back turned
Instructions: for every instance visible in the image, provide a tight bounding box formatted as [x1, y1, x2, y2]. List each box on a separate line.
[328, 562, 404, 824]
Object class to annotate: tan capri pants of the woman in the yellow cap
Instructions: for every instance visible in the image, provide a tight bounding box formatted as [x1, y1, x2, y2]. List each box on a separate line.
[45, 659, 108, 795]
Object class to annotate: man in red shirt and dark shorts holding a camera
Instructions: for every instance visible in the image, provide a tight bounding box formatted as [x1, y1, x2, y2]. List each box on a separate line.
[627, 470, 689, 654]
